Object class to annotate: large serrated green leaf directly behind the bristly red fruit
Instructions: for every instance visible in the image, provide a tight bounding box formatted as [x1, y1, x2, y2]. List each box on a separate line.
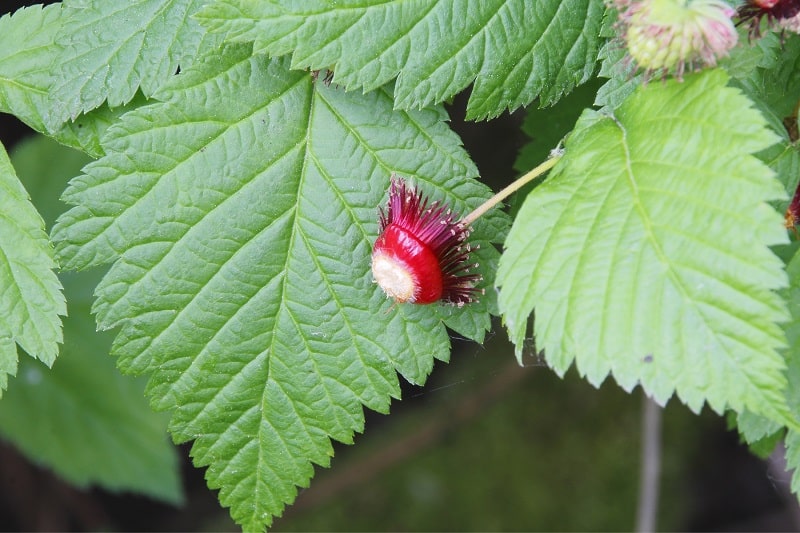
[54, 46, 507, 530]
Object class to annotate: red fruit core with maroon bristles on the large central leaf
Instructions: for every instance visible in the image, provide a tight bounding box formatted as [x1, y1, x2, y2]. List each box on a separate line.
[372, 174, 482, 306]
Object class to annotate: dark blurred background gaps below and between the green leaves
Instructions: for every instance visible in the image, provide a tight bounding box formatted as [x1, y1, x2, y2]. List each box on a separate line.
[0, 1, 800, 531]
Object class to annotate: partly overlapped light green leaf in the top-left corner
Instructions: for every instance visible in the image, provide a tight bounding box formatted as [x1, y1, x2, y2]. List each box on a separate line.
[0, 4, 61, 131]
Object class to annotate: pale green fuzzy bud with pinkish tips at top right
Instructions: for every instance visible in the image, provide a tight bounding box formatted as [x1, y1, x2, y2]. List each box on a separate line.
[613, 0, 738, 79]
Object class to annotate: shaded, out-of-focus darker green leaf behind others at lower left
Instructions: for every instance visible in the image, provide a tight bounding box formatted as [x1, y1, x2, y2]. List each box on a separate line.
[0, 133, 182, 503]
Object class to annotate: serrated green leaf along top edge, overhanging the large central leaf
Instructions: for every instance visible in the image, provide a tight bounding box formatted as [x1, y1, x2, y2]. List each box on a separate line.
[198, 0, 604, 118]
